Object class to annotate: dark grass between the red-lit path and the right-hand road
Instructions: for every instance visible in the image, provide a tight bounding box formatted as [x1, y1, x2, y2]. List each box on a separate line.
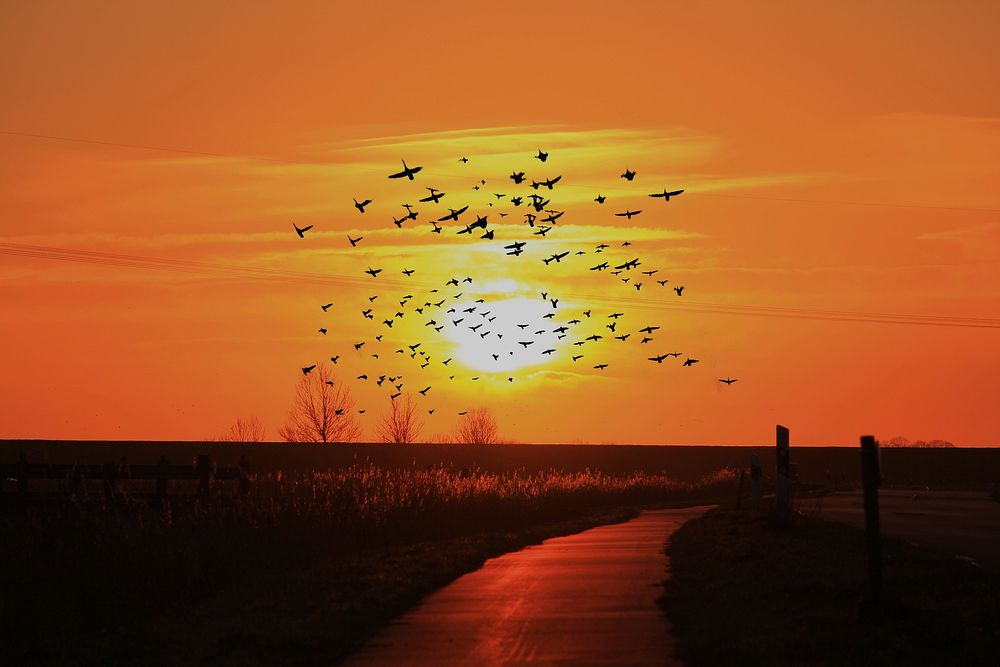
[660, 509, 1000, 665]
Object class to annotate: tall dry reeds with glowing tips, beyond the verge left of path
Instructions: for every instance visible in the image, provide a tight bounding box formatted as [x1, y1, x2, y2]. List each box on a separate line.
[0, 464, 735, 662]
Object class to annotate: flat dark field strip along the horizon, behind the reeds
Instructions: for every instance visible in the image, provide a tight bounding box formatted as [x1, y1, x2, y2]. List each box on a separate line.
[0, 434, 1000, 491]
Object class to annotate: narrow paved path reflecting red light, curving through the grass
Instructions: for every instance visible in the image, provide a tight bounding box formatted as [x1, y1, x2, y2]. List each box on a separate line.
[346, 507, 709, 667]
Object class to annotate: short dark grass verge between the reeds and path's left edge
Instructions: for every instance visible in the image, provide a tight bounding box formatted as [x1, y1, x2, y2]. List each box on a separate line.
[22, 509, 637, 666]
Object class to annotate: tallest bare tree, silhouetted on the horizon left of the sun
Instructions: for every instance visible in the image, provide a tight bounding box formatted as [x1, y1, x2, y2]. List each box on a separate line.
[278, 364, 361, 442]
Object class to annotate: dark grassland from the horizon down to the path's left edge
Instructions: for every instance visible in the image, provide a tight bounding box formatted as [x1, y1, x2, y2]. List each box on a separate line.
[0, 441, 1000, 664]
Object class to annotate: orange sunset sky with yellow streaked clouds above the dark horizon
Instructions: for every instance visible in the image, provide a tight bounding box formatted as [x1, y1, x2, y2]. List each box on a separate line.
[0, 2, 1000, 445]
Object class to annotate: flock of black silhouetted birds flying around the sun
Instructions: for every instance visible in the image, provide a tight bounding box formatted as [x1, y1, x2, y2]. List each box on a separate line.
[293, 150, 737, 422]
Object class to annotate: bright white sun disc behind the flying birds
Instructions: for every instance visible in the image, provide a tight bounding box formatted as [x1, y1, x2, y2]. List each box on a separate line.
[445, 297, 564, 372]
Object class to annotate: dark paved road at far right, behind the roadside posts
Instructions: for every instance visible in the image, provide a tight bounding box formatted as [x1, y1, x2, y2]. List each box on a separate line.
[816, 490, 1000, 572]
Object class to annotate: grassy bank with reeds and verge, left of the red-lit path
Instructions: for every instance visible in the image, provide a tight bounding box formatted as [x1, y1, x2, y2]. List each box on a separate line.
[0, 465, 734, 665]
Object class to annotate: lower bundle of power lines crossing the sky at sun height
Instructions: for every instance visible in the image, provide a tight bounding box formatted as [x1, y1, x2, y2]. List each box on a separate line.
[0, 243, 1000, 329]
